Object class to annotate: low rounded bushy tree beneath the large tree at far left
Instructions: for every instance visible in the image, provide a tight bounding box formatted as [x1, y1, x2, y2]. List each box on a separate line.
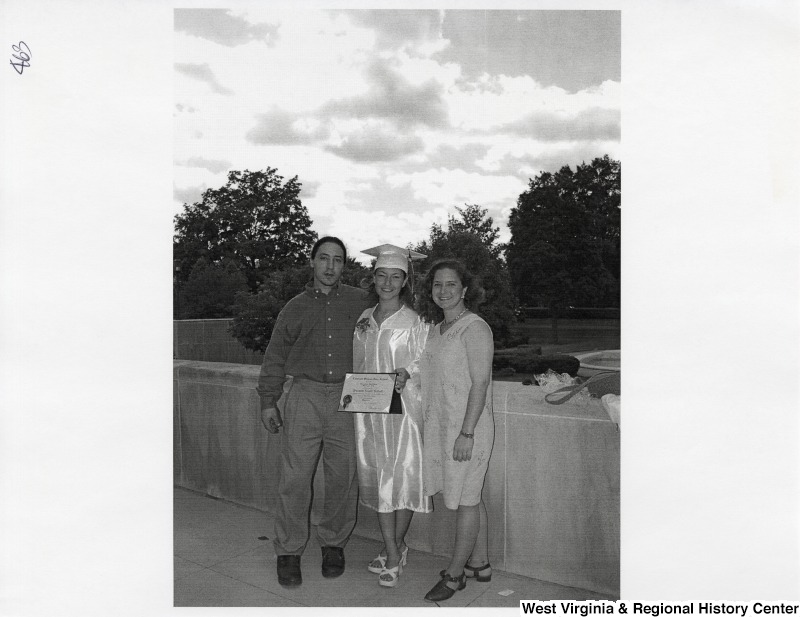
[175, 258, 247, 319]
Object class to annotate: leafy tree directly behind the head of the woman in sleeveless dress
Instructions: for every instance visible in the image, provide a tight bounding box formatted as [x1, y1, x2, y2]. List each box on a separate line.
[414, 205, 515, 347]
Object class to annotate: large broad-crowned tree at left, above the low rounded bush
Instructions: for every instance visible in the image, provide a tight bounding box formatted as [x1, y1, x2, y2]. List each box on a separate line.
[173, 167, 317, 291]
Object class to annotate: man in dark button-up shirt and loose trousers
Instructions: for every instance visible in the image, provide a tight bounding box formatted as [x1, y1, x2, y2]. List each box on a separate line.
[257, 236, 368, 587]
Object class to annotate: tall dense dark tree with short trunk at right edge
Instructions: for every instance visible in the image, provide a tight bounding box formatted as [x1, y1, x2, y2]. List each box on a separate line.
[506, 155, 621, 341]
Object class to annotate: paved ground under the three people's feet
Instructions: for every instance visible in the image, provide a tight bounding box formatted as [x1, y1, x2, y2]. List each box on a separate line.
[173, 488, 612, 610]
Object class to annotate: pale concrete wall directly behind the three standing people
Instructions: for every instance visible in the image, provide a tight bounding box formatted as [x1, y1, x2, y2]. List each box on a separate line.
[174, 360, 620, 597]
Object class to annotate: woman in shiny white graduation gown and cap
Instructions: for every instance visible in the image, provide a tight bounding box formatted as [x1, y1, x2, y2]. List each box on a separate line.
[353, 245, 433, 587]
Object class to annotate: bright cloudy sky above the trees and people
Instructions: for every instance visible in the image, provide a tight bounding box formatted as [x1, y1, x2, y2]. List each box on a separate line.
[173, 8, 620, 262]
